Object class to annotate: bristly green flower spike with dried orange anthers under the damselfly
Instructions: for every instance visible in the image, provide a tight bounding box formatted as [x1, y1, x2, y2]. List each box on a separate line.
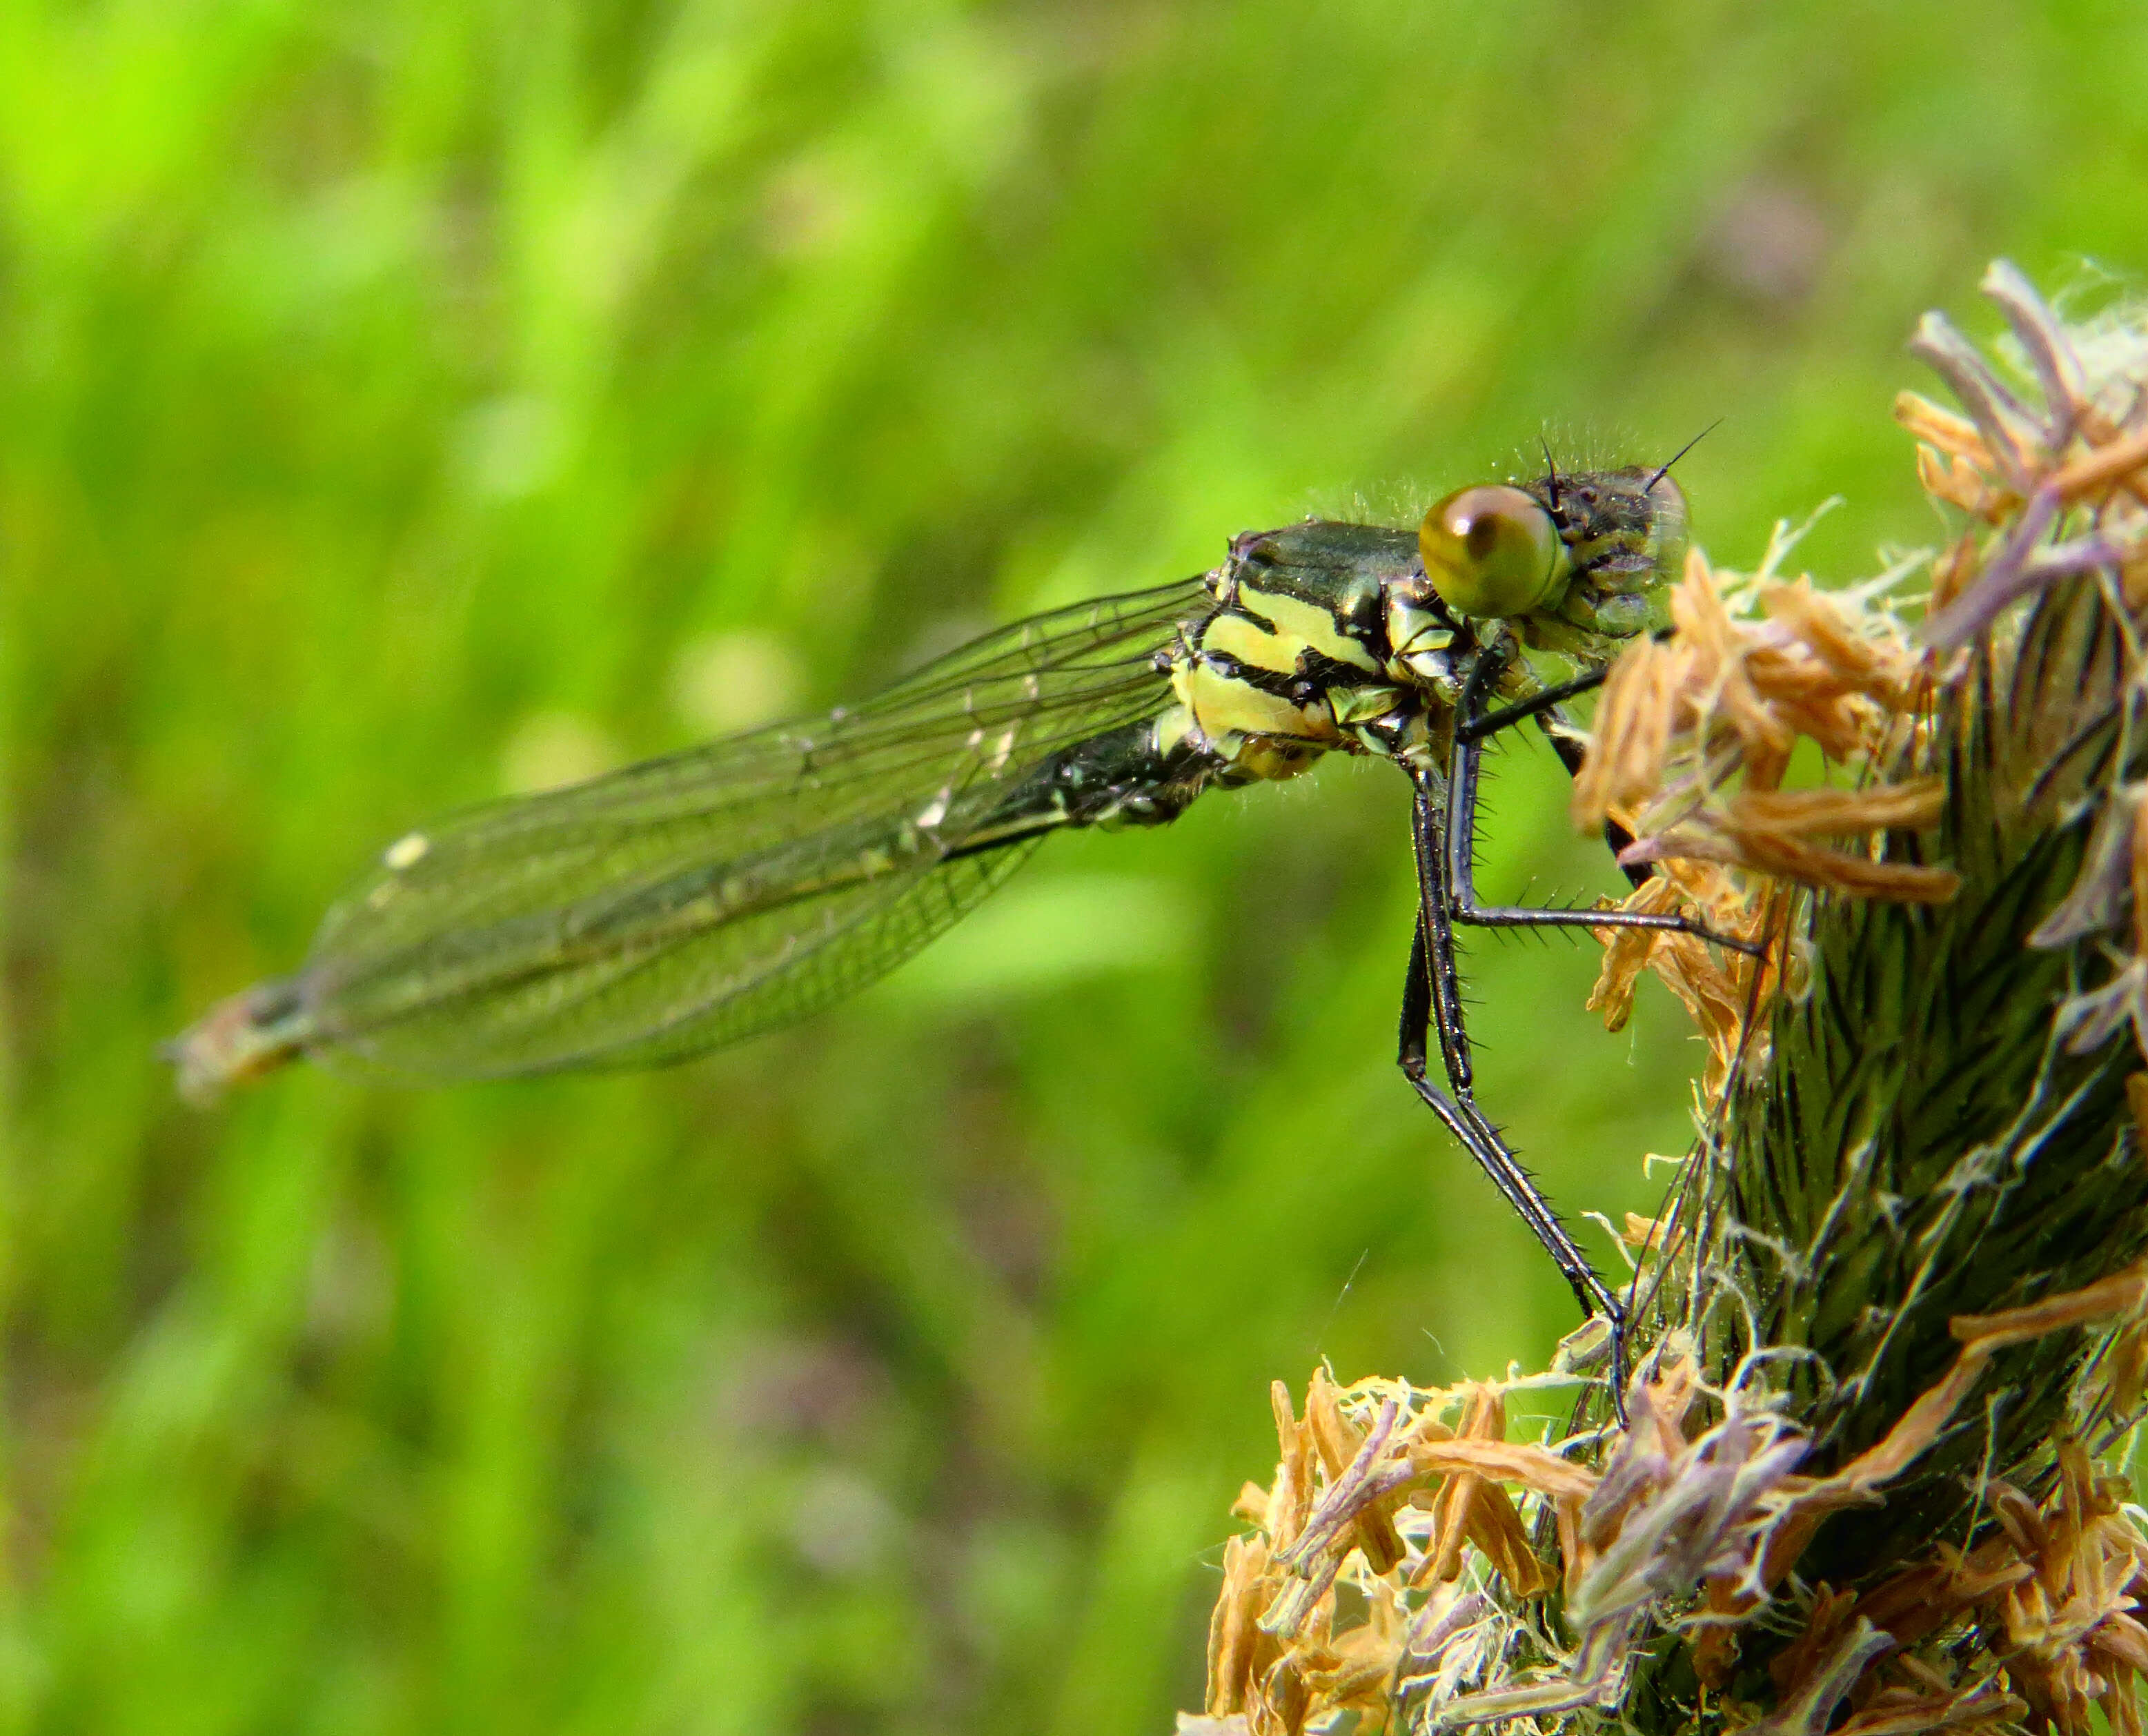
[1185, 264, 2148, 1736]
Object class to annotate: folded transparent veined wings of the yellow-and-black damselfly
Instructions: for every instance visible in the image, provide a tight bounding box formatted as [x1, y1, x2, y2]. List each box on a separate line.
[292, 580, 1208, 1076]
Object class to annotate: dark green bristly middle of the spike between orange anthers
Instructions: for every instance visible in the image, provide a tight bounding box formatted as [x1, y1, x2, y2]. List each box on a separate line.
[1725, 582, 2148, 1586]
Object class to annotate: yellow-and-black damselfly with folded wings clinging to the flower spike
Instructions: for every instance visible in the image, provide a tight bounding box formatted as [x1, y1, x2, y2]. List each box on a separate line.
[170, 453, 1744, 1392]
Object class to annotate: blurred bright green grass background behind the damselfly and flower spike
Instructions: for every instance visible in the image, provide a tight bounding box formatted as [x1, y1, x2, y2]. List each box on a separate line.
[0, 0, 2148, 1736]
